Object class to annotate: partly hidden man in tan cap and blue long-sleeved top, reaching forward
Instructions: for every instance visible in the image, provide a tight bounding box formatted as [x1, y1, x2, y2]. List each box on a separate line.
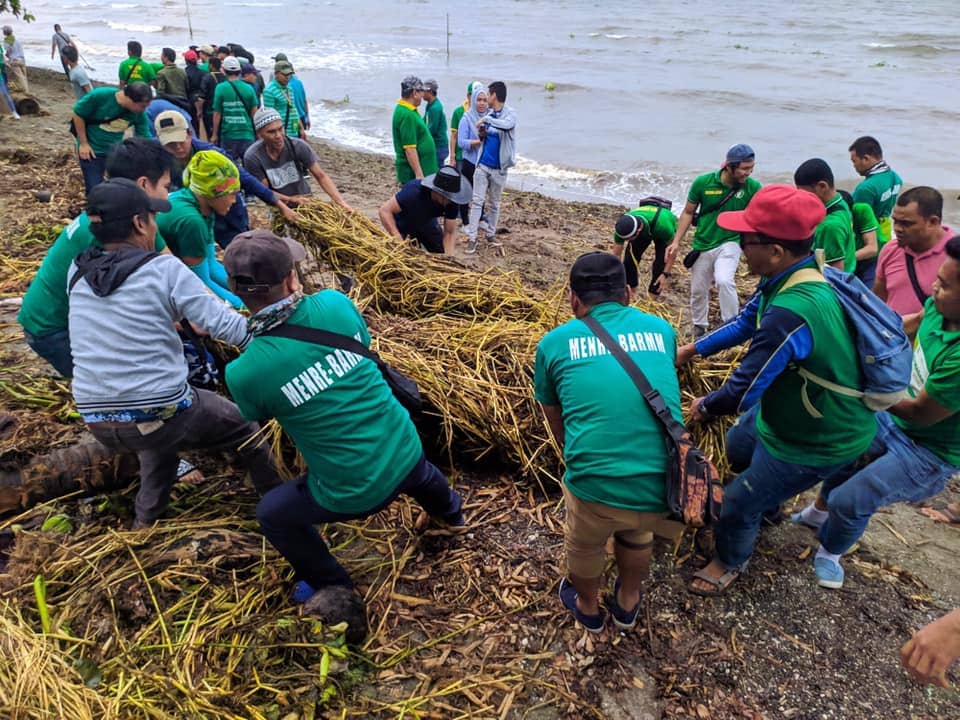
[154, 111, 295, 248]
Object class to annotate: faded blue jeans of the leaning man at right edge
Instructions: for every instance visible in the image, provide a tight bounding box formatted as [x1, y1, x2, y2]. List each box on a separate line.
[820, 412, 958, 555]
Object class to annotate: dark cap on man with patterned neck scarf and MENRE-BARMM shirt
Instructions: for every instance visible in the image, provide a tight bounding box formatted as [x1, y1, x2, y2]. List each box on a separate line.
[223, 230, 307, 295]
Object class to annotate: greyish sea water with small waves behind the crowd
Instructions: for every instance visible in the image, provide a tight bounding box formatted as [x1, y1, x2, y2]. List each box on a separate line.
[9, 0, 960, 204]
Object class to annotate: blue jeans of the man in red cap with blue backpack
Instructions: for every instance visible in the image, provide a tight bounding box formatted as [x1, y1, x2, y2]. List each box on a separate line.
[715, 442, 855, 568]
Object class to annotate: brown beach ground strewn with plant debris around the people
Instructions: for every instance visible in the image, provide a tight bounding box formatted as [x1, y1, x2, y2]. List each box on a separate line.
[0, 69, 960, 720]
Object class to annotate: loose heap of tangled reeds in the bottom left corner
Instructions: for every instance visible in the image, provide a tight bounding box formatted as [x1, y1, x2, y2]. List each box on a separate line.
[0, 510, 347, 720]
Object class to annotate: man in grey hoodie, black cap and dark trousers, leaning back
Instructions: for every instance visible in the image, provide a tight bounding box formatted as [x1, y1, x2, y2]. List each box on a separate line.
[67, 179, 279, 528]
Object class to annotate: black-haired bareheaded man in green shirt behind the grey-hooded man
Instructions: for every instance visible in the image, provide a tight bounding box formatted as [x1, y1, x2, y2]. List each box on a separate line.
[17, 138, 173, 377]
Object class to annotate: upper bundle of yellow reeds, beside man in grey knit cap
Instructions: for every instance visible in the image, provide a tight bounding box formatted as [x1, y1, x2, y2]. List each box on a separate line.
[282, 201, 563, 325]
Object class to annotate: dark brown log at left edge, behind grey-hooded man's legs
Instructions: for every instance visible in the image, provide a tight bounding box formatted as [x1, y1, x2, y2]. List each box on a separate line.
[0, 436, 139, 516]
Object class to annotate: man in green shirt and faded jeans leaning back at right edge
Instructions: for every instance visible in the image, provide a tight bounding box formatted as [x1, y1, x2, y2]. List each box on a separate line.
[793, 237, 960, 588]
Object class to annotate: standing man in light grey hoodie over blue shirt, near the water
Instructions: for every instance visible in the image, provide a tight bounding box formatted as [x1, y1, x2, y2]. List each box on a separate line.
[466, 81, 517, 255]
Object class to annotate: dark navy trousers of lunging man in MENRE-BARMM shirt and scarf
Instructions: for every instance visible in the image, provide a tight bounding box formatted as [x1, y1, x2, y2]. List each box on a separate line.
[257, 455, 462, 590]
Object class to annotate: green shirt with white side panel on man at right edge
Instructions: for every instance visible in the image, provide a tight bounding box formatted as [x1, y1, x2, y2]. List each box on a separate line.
[893, 298, 960, 467]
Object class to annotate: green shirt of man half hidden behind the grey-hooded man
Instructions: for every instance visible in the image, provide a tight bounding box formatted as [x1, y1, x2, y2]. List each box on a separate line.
[17, 212, 167, 336]
